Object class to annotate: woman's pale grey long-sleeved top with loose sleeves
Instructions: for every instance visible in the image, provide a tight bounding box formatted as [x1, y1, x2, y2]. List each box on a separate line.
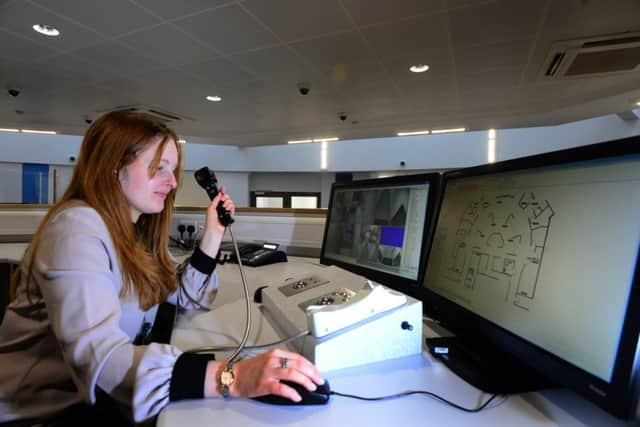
[0, 206, 217, 422]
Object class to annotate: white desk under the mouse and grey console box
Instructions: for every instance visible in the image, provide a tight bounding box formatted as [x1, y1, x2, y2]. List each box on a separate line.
[158, 258, 640, 427]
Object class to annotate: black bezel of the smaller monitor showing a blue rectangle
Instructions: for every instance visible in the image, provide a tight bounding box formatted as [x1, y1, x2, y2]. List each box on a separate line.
[320, 172, 441, 295]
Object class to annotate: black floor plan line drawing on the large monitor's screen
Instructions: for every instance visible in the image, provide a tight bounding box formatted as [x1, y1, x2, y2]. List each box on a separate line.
[444, 191, 555, 310]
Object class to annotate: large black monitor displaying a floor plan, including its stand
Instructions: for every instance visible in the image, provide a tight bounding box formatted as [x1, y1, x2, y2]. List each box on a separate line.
[418, 137, 640, 418]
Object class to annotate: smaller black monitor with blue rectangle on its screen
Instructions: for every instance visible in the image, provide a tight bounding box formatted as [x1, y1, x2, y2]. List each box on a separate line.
[320, 173, 440, 293]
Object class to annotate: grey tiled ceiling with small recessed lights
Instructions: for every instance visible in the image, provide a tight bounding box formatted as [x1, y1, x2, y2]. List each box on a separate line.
[0, 0, 640, 146]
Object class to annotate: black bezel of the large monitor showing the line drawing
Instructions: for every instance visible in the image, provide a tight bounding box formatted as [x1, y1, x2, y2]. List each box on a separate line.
[416, 136, 640, 419]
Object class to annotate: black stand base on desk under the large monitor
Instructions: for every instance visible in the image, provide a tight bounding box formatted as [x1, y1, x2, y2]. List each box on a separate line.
[427, 337, 556, 394]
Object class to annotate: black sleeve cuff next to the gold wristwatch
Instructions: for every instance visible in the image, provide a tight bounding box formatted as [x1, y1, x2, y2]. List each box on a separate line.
[169, 353, 215, 402]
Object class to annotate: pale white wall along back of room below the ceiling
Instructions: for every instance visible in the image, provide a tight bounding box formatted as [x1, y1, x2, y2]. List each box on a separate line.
[0, 109, 640, 206]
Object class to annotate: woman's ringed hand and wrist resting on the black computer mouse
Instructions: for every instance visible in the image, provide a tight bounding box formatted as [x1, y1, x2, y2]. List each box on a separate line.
[205, 349, 324, 402]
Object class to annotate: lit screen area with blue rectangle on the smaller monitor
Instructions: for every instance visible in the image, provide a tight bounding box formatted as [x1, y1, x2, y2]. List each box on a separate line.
[324, 183, 429, 280]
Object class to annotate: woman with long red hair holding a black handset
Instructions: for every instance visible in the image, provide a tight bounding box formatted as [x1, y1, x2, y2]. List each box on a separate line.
[0, 111, 323, 426]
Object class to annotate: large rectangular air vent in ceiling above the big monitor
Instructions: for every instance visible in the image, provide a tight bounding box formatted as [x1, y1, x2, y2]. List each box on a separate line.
[542, 33, 640, 79]
